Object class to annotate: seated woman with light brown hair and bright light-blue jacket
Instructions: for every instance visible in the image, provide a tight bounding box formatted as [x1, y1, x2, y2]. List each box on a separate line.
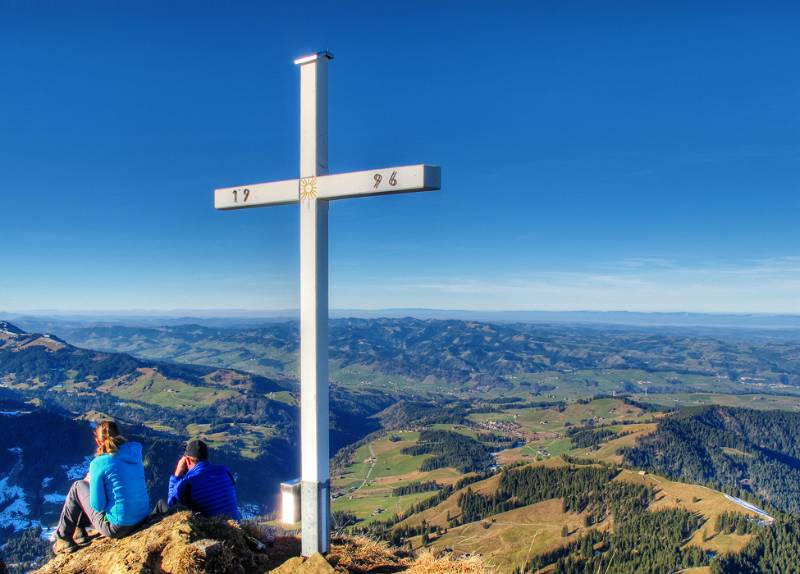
[53, 421, 150, 554]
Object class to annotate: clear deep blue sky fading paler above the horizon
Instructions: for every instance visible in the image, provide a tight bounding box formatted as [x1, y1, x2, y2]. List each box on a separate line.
[0, 0, 800, 313]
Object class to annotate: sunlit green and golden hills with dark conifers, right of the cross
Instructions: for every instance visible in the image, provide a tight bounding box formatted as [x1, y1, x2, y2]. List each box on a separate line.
[324, 398, 800, 574]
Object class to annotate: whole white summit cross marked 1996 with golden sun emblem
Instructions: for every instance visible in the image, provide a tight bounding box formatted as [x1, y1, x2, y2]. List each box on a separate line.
[214, 52, 441, 556]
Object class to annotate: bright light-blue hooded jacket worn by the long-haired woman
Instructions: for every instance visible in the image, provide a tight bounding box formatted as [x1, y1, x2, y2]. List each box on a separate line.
[89, 442, 150, 526]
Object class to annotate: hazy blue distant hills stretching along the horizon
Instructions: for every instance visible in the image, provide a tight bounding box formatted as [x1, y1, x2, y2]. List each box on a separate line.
[25, 318, 800, 390]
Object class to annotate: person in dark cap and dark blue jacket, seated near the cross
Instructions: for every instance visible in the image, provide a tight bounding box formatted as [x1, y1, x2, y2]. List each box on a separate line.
[167, 440, 242, 521]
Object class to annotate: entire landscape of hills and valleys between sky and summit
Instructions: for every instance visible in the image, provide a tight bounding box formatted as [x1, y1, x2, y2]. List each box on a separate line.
[0, 319, 800, 574]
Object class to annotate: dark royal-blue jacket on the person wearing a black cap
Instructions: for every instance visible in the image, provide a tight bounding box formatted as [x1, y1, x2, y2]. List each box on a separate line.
[167, 461, 242, 521]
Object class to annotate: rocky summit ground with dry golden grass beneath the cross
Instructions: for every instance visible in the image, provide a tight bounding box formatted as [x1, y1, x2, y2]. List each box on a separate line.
[33, 512, 485, 574]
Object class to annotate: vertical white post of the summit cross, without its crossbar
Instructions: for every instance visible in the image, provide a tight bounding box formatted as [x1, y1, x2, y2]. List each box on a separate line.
[295, 52, 333, 556]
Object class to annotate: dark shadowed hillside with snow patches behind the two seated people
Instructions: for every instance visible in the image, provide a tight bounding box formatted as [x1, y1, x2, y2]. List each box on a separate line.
[0, 322, 391, 552]
